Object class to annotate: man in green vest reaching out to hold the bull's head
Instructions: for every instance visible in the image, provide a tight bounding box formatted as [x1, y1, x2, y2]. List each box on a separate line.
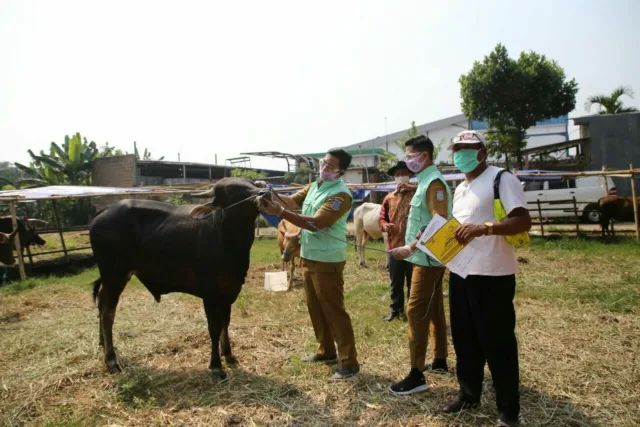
[261, 149, 360, 380]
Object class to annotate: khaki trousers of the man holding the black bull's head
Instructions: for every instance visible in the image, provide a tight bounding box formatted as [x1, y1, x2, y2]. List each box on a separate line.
[302, 259, 358, 368]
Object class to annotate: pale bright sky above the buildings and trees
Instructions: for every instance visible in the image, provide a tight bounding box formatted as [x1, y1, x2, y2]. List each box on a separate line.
[0, 0, 640, 169]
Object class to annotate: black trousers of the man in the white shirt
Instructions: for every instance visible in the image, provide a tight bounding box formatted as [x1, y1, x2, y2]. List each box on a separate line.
[449, 273, 520, 419]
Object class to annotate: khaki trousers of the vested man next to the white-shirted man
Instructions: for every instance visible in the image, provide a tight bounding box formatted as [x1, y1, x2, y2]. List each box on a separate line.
[407, 265, 447, 370]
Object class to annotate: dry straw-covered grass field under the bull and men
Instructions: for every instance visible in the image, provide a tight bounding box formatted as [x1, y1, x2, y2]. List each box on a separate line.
[0, 236, 640, 427]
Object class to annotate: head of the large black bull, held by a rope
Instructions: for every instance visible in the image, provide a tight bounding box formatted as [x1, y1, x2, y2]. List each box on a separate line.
[189, 178, 261, 220]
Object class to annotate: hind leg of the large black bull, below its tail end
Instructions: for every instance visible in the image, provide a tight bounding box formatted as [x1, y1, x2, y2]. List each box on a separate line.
[98, 276, 127, 374]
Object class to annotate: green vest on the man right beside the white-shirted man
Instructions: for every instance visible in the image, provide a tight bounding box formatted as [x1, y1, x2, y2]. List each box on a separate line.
[405, 165, 453, 267]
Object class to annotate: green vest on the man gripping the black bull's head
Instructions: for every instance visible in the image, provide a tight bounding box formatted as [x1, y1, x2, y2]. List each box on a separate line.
[300, 179, 351, 262]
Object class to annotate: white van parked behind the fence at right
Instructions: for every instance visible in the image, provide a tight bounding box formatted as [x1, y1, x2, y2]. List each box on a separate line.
[522, 176, 616, 224]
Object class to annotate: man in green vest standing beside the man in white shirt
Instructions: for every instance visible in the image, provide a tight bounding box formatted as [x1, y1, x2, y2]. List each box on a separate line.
[389, 135, 453, 395]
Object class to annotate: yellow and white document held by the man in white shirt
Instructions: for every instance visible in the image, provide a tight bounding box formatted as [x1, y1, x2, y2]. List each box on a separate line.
[417, 215, 477, 278]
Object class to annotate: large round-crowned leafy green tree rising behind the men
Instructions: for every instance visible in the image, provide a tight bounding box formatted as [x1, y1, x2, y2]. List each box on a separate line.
[459, 44, 578, 168]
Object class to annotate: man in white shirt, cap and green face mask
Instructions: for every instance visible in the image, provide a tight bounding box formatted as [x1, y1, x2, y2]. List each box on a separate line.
[443, 131, 531, 426]
